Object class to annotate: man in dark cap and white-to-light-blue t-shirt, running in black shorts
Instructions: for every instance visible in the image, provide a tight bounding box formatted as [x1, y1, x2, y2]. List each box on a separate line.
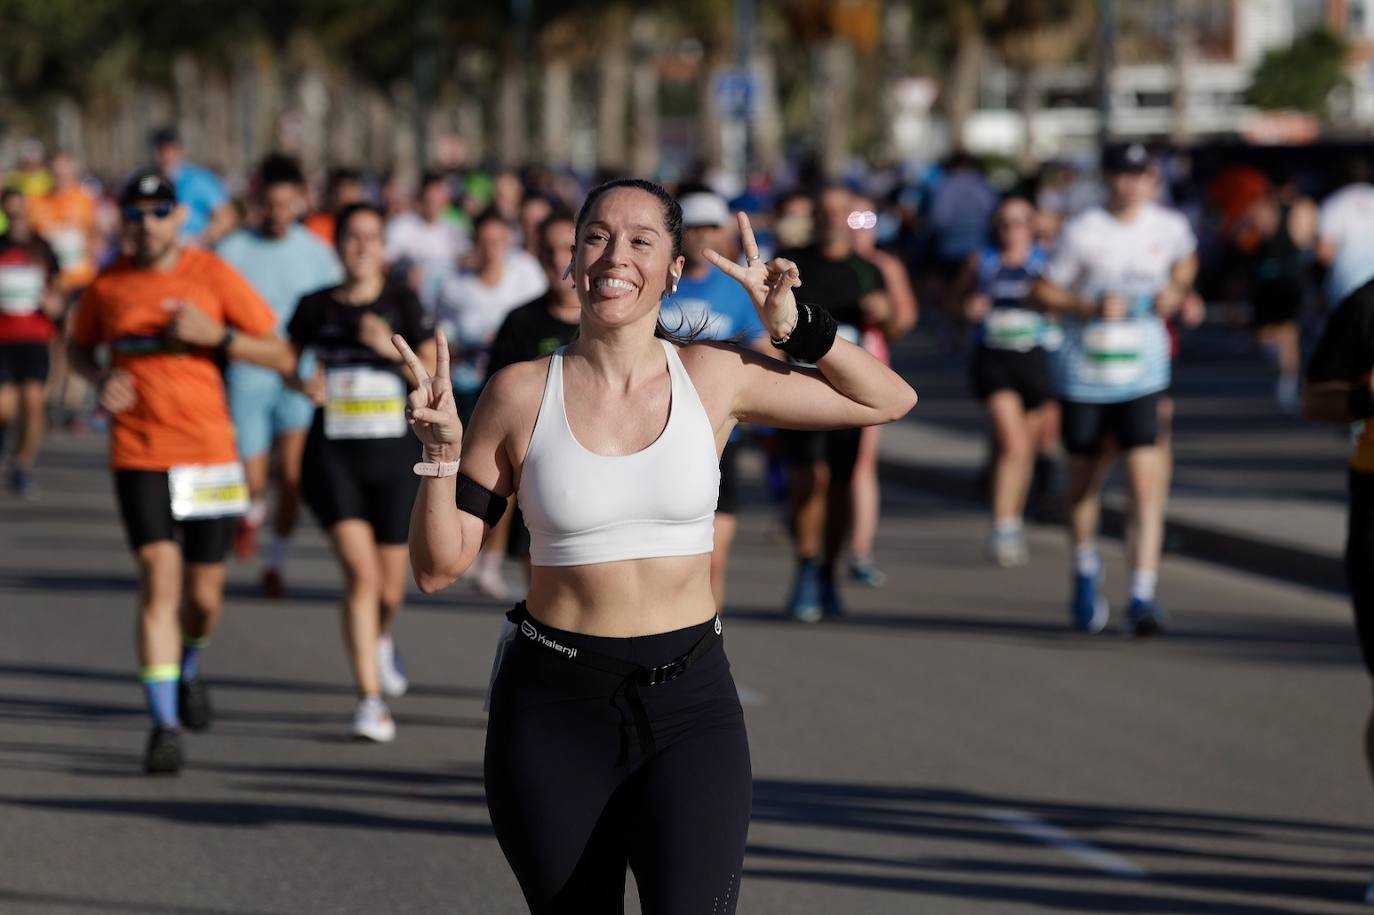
[1032, 144, 1197, 635]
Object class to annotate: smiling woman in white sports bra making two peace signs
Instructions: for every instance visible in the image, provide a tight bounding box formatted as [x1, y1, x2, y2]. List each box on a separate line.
[396, 180, 916, 915]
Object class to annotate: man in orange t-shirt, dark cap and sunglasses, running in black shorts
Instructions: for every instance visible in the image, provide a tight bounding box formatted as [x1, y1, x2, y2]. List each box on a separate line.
[70, 172, 295, 773]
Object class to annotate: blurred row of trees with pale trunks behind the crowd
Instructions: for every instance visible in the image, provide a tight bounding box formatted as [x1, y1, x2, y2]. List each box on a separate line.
[0, 0, 1264, 185]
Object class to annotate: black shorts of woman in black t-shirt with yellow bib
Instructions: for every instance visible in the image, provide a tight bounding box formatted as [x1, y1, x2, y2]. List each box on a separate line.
[301, 411, 420, 544]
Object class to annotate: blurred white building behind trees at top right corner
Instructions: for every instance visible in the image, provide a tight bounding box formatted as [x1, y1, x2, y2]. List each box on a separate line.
[965, 0, 1374, 159]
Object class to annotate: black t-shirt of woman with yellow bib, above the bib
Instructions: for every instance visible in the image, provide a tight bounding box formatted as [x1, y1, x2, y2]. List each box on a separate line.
[286, 280, 430, 372]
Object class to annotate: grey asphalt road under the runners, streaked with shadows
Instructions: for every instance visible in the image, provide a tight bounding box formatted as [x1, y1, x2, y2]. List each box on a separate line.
[0, 437, 1374, 915]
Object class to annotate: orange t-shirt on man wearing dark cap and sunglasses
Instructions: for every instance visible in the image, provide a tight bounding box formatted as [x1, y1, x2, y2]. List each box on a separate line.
[71, 249, 276, 470]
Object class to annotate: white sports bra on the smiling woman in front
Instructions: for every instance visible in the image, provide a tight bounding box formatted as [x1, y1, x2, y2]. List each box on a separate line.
[518, 341, 720, 566]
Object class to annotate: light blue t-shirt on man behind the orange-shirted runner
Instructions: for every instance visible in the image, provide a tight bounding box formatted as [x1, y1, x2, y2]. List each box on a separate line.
[216, 225, 344, 330]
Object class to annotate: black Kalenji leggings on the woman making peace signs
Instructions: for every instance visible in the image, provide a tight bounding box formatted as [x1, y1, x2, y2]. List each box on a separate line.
[486, 610, 753, 915]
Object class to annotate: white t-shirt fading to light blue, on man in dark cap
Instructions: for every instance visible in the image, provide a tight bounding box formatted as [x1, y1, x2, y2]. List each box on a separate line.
[1044, 203, 1197, 403]
